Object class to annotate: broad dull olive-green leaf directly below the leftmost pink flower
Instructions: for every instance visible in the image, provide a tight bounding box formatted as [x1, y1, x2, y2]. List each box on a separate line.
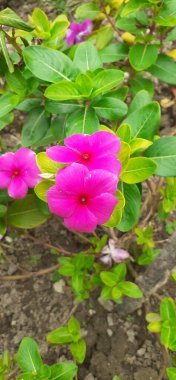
[7, 194, 48, 228]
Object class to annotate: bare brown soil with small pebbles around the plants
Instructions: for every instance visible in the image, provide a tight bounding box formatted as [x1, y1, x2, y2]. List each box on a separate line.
[0, 0, 176, 380]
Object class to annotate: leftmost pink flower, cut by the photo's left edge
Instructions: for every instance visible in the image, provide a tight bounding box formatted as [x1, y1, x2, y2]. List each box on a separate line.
[0, 148, 41, 199]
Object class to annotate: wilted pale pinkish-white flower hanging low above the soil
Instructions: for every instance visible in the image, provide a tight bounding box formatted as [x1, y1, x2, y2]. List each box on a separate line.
[100, 239, 130, 267]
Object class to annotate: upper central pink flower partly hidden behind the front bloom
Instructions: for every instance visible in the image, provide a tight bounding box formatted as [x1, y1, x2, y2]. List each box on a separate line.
[46, 131, 121, 176]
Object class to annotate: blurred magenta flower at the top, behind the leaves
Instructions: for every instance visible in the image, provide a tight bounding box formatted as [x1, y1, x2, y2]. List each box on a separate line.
[66, 18, 93, 46]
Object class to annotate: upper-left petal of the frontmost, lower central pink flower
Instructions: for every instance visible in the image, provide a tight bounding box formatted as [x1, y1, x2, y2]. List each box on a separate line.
[56, 164, 89, 194]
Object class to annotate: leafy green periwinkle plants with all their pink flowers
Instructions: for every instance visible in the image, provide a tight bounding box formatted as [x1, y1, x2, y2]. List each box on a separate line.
[0, 0, 176, 380]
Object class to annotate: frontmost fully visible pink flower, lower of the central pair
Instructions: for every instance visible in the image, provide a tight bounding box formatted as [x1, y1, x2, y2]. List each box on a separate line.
[47, 164, 118, 232]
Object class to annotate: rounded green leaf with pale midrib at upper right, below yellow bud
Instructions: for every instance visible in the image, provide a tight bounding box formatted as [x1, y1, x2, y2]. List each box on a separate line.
[129, 43, 158, 71]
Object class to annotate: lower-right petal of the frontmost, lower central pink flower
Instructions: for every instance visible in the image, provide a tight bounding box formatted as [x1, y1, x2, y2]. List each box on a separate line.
[88, 194, 118, 224]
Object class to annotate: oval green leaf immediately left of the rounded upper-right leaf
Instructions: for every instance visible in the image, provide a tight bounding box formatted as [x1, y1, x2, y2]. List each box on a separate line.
[99, 43, 129, 63]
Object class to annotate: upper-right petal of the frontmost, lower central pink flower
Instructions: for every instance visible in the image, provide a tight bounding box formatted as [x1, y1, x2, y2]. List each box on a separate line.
[82, 171, 117, 198]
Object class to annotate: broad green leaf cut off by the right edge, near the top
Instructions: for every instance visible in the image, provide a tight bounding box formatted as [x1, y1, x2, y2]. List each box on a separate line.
[148, 54, 176, 84]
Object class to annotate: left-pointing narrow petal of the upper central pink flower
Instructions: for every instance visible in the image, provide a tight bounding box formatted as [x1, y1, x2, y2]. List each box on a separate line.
[46, 146, 80, 164]
